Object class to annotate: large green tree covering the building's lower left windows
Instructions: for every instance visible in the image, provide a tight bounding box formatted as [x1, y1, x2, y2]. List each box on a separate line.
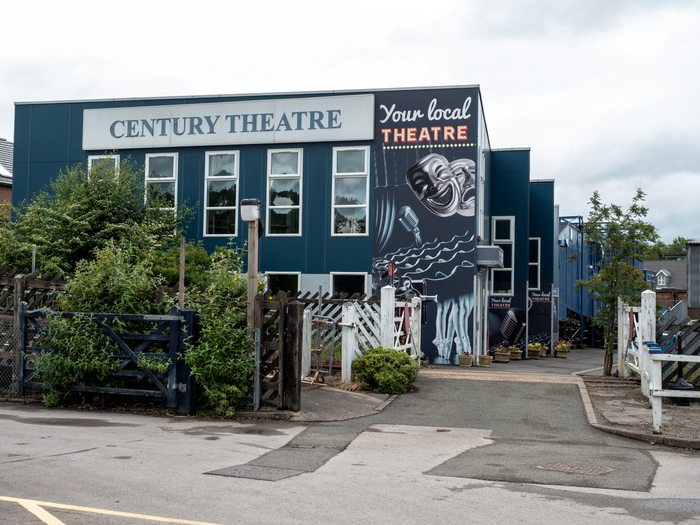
[0, 160, 192, 272]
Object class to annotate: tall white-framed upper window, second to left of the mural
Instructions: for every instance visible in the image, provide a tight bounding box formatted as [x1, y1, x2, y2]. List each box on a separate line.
[266, 149, 304, 236]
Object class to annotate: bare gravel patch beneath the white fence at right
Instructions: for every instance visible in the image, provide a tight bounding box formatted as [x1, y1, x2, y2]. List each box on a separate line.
[584, 377, 700, 440]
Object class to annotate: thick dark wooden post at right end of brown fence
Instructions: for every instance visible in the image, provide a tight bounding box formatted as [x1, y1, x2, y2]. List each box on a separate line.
[280, 301, 304, 412]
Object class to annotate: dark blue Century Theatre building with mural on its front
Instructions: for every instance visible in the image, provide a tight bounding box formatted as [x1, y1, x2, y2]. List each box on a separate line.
[13, 86, 558, 363]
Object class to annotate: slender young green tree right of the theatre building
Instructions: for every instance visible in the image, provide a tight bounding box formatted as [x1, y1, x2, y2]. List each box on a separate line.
[575, 189, 659, 375]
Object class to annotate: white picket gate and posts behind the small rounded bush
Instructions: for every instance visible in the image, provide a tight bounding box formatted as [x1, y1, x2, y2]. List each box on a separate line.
[301, 286, 421, 381]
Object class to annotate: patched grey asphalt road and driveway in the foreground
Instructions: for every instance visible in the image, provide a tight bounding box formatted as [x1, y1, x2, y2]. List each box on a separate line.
[0, 375, 700, 525]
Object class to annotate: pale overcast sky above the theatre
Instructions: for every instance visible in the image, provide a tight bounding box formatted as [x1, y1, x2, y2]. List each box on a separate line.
[0, 0, 700, 242]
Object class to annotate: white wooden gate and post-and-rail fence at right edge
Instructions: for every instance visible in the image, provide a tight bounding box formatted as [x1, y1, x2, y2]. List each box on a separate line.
[617, 290, 700, 434]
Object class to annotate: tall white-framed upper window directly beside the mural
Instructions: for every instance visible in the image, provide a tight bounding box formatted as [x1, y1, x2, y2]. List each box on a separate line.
[331, 146, 369, 236]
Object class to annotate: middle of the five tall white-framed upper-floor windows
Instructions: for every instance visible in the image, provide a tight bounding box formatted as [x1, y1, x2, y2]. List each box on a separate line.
[204, 151, 239, 237]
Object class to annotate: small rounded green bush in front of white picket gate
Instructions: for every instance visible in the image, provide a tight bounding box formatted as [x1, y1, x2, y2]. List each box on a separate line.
[353, 347, 418, 394]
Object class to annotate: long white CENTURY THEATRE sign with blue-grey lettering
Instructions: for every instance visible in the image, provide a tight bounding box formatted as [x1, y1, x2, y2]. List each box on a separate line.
[83, 95, 374, 150]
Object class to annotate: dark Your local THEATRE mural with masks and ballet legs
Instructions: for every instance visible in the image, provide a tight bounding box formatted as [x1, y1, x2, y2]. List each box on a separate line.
[372, 89, 478, 364]
